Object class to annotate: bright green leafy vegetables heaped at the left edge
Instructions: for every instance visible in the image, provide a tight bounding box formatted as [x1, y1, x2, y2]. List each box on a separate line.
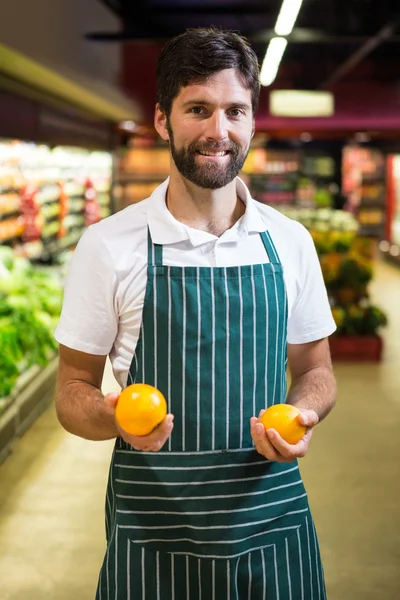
[0, 246, 63, 414]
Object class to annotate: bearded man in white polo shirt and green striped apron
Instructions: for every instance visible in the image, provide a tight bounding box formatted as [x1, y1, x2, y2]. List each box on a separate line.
[56, 28, 336, 600]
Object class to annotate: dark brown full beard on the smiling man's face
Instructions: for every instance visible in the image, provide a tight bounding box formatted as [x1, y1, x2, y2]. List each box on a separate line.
[167, 125, 249, 190]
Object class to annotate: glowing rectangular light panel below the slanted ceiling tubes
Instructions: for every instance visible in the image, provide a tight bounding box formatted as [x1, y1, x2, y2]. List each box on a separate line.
[269, 90, 335, 117]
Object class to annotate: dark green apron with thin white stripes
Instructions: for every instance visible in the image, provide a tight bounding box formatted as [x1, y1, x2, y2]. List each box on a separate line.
[96, 227, 326, 600]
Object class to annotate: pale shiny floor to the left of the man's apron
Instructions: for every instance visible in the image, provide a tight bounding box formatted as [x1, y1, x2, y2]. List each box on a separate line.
[0, 363, 119, 600]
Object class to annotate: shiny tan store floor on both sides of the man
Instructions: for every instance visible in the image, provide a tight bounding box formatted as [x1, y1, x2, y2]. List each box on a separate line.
[0, 264, 400, 600]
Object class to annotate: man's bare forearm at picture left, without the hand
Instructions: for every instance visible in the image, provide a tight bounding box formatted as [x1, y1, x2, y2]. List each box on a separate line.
[56, 381, 119, 441]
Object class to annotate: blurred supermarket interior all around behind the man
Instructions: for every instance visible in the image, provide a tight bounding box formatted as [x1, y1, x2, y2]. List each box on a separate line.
[0, 0, 400, 600]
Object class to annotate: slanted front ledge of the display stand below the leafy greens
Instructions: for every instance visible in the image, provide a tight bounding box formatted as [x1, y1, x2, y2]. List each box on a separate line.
[0, 356, 58, 463]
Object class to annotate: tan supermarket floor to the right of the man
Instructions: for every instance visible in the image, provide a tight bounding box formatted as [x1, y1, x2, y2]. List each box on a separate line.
[302, 264, 400, 600]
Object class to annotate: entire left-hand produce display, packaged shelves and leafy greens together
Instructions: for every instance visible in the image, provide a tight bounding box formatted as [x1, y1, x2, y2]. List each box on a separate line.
[0, 139, 113, 420]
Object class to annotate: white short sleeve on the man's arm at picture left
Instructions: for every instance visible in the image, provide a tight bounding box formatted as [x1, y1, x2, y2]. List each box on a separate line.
[55, 227, 118, 355]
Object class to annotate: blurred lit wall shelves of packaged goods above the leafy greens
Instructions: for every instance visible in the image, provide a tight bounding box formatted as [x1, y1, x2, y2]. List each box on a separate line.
[0, 140, 112, 263]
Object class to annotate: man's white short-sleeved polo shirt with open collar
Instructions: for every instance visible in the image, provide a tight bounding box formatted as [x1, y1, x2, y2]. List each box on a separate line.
[55, 178, 336, 387]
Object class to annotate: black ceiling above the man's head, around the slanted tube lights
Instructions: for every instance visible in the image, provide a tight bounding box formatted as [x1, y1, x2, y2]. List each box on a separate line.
[87, 0, 400, 137]
